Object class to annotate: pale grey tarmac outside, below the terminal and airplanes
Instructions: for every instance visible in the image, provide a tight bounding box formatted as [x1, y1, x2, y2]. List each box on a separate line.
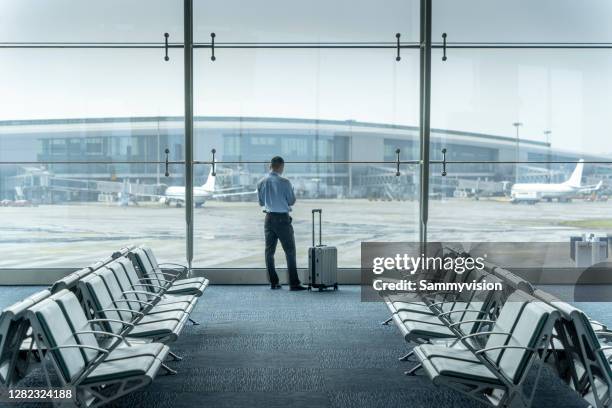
[0, 198, 612, 268]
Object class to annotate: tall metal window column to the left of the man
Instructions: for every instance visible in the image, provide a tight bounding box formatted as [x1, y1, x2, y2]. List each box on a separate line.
[183, 0, 193, 274]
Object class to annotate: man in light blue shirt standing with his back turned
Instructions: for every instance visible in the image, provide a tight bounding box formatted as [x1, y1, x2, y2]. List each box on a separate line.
[257, 156, 306, 290]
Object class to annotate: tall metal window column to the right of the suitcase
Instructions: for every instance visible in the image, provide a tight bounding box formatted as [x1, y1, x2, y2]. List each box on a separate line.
[419, 0, 431, 243]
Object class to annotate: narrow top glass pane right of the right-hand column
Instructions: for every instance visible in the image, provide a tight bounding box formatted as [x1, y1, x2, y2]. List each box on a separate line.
[432, 0, 612, 43]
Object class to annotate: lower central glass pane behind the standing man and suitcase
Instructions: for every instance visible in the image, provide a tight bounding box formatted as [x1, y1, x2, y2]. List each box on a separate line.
[194, 163, 418, 268]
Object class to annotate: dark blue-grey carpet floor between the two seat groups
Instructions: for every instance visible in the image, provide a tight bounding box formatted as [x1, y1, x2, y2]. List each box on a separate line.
[0, 286, 586, 408]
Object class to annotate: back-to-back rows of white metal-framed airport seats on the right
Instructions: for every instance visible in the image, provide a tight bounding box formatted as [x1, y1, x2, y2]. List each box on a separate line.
[383, 245, 612, 408]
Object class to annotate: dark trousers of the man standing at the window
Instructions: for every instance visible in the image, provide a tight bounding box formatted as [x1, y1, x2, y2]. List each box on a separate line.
[264, 213, 300, 287]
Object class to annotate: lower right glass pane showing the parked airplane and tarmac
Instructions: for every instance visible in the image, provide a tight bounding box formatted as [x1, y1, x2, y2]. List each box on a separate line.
[428, 163, 612, 319]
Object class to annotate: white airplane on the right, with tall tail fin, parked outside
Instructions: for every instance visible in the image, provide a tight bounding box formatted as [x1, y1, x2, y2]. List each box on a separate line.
[510, 159, 603, 204]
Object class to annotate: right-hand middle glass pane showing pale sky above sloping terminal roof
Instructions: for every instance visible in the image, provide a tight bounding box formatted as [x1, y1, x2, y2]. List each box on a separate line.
[431, 49, 612, 161]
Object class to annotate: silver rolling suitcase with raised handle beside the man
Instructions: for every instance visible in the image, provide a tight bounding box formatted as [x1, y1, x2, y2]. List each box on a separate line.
[308, 209, 338, 291]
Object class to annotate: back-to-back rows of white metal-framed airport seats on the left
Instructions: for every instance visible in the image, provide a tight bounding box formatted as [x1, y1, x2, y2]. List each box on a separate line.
[0, 246, 208, 407]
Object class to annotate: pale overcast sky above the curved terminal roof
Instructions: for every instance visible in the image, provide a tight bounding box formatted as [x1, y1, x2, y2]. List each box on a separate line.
[0, 0, 612, 153]
